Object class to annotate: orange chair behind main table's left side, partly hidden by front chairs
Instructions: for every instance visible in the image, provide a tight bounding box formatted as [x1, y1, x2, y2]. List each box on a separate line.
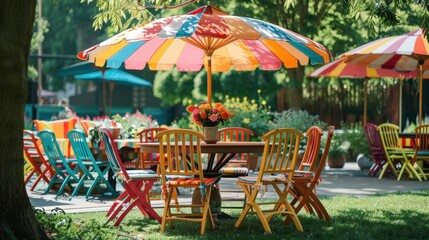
[137, 127, 179, 211]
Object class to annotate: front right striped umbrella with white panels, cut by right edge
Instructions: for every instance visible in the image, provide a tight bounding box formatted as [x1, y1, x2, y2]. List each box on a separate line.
[339, 29, 429, 123]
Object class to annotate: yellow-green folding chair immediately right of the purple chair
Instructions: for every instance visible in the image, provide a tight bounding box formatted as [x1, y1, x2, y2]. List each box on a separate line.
[377, 123, 426, 181]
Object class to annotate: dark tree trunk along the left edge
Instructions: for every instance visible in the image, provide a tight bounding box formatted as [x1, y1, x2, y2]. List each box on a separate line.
[0, 0, 47, 239]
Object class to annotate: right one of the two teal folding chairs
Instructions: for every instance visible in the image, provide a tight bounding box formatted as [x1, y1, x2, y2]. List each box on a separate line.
[67, 129, 116, 199]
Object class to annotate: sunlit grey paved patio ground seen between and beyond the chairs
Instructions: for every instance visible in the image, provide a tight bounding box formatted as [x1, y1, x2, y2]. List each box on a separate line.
[27, 163, 429, 213]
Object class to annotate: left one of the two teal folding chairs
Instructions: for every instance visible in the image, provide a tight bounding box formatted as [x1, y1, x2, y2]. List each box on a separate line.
[37, 129, 79, 199]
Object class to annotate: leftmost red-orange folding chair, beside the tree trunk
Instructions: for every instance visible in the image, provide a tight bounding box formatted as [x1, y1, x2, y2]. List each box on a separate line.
[23, 130, 54, 191]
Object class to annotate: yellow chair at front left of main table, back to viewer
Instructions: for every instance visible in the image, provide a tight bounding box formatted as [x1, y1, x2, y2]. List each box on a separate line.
[156, 129, 218, 235]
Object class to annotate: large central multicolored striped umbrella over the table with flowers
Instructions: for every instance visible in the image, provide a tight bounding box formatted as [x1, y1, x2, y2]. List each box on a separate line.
[78, 5, 331, 103]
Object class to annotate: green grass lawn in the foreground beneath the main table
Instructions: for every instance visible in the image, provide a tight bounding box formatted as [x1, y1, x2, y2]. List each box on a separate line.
[36, 191, 429, 240]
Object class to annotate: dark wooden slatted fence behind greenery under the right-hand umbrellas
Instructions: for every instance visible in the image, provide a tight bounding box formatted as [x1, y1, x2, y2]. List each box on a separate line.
[296, 79, 392, 126]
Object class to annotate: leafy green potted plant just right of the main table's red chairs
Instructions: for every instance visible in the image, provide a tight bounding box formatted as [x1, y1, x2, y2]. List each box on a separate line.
[328, 134, 350, 168]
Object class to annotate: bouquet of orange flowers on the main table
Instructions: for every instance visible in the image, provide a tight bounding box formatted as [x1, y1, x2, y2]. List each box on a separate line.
[186, 102, 233, 127]
